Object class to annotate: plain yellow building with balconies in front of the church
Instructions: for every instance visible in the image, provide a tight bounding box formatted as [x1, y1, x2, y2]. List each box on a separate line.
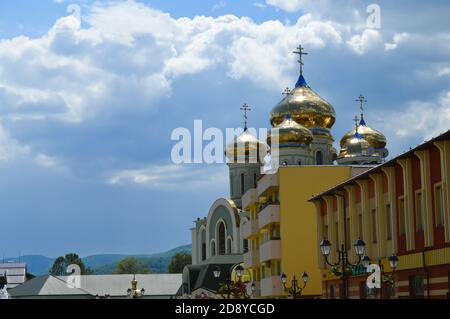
[242, 165, 365, 297]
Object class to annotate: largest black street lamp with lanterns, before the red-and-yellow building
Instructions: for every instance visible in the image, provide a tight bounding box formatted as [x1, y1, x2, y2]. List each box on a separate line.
[320, 238, 370, 299]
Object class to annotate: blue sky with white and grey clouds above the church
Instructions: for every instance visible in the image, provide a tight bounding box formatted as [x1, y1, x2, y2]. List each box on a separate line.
[0, 0, 450, 256]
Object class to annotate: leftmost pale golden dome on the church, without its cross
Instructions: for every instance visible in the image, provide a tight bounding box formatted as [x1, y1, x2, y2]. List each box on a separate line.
[225, 129, 267, 163]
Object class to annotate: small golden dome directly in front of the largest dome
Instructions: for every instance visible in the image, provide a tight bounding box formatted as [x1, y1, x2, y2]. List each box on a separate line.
[267, 114, 313, 146]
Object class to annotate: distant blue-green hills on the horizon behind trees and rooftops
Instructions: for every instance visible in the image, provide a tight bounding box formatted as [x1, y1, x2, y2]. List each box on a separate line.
[5, 245, 192, 276]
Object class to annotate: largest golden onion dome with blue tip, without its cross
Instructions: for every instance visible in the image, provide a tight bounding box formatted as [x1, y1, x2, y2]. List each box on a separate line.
[270, 75, 336, 129]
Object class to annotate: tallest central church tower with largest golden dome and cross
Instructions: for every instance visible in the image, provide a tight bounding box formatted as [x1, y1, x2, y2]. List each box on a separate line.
[270, 45, 336, 165]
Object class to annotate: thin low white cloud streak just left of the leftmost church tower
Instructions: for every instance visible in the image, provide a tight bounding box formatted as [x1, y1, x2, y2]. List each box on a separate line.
[107, 164, 228, 191]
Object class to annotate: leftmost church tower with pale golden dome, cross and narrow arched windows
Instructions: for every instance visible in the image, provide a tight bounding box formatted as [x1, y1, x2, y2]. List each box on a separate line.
[225, 104, 267, 208]
